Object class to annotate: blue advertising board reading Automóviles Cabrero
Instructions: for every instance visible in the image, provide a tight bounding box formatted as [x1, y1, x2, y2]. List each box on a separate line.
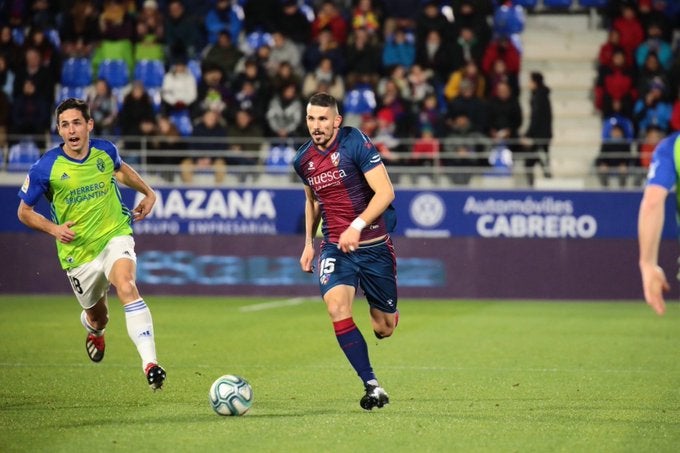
[394, 190, 677, 239]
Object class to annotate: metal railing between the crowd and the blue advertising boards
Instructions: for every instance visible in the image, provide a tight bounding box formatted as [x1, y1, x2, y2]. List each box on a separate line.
[0, 134, 647, 189]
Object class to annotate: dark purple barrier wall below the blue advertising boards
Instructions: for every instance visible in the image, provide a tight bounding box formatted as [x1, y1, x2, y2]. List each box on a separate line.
[0, 233, 678, 300]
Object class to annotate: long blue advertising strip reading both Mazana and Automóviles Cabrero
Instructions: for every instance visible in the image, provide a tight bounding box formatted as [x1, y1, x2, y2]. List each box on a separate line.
[0, 187, 677, 239]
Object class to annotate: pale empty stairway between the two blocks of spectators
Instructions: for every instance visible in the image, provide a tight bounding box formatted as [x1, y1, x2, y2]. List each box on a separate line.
[520, 14, 606, 188]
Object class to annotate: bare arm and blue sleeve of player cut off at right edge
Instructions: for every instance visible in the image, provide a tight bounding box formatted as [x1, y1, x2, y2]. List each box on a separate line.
[638, 133, 680, 315]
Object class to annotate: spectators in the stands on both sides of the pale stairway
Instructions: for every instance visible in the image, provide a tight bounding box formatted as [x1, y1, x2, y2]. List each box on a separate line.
[0, 0, 680, 184]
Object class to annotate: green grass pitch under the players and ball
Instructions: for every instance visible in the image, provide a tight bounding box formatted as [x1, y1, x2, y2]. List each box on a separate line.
[0, 296, 680, 452]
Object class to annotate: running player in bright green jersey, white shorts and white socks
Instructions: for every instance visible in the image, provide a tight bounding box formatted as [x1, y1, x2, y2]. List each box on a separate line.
[18, 98, 165, 390]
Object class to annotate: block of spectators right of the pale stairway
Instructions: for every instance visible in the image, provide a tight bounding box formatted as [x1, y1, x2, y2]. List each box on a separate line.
[594, 0, 680, 187]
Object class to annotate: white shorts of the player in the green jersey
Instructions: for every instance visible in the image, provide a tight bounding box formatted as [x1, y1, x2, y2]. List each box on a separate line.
[66, 236, 137, 309]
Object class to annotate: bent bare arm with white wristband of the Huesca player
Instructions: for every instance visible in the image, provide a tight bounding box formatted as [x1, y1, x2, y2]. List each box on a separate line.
[338, 163, 394, 253]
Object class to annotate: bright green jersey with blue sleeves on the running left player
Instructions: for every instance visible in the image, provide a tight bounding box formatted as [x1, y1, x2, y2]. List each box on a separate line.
[19, 139, 132, 269]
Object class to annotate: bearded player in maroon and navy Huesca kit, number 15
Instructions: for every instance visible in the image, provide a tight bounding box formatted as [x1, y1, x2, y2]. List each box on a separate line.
[293, 93, 399, 410]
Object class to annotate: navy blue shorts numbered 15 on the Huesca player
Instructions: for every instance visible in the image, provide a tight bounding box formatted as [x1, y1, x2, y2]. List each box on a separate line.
[318, 236, 397, 313]
